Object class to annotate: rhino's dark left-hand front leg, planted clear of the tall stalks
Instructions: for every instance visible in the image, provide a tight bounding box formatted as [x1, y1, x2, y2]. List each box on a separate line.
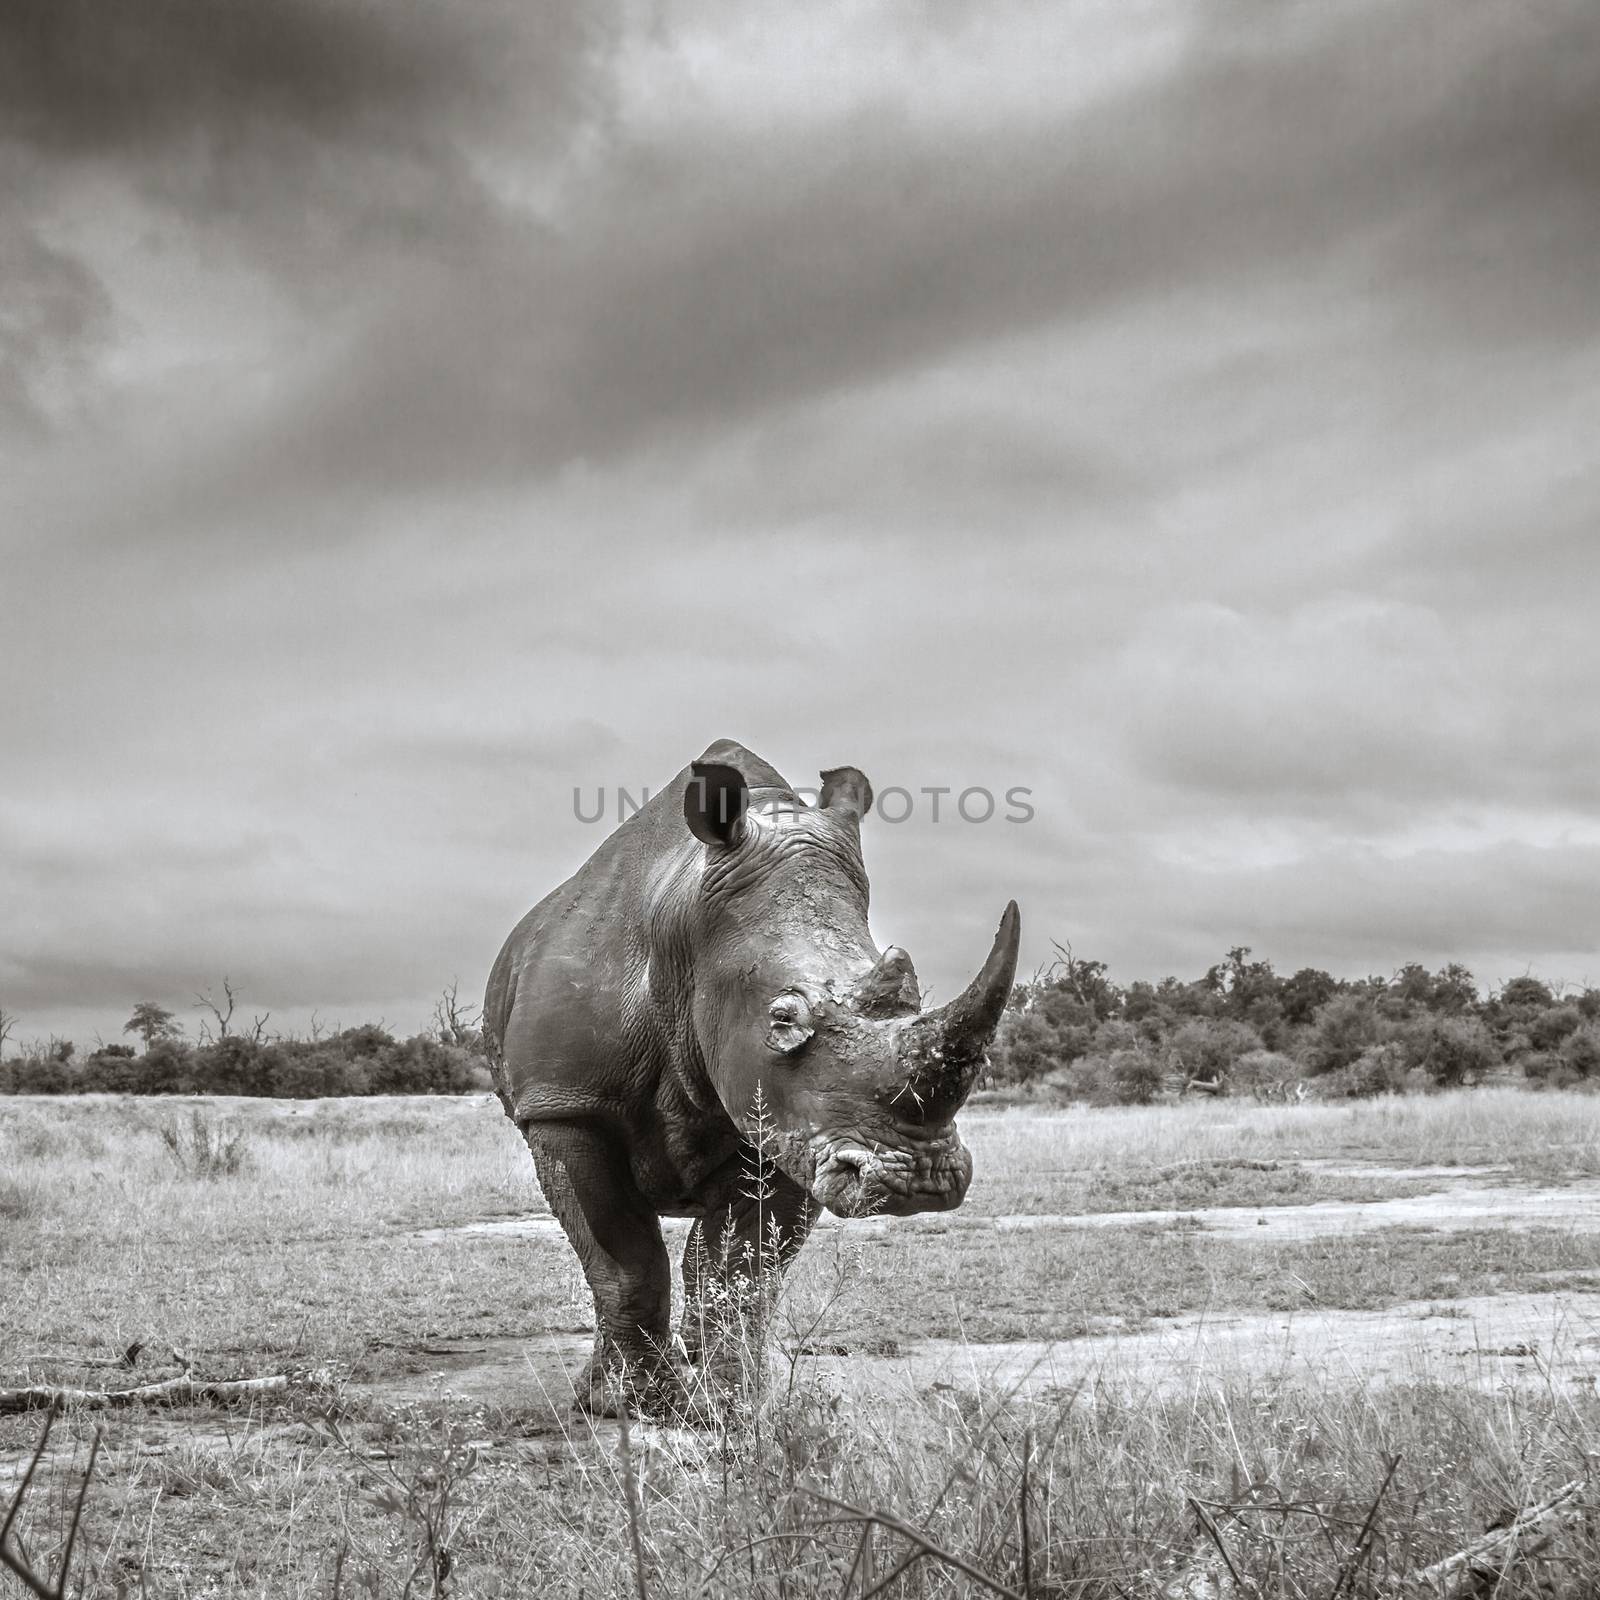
[523, 1122, 682, 1416]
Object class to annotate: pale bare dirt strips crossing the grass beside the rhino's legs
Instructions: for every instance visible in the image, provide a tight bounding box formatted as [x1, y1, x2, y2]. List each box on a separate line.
[377, 1163, 1600, 1422]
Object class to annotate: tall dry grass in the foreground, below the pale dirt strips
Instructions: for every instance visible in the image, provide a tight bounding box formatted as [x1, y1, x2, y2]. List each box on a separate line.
[0, 1356, 1600, 1600]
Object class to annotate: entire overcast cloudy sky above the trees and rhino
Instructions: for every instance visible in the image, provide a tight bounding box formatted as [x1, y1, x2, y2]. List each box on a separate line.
[0, 0, 1600, 1045]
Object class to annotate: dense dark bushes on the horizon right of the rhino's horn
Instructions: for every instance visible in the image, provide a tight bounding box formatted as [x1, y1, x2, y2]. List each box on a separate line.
[989, 946, 1600, 1104]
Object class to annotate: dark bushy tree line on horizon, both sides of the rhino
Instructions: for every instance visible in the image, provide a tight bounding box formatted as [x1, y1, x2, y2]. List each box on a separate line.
[0, 946, 1600, 1104]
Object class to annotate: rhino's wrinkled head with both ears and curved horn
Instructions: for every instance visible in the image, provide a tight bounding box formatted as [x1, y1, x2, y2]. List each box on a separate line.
[683, 762, 1021, 1216]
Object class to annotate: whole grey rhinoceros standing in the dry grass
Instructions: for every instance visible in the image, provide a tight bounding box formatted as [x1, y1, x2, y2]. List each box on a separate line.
[483, 741, 1021, 1411]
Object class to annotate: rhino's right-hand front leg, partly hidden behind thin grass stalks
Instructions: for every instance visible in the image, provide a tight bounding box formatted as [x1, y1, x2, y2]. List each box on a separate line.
[683, 1173, 819, 1374]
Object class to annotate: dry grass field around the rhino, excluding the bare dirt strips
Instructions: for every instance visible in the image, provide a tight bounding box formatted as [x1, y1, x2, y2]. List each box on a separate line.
[0, 1091, 1600, 1597]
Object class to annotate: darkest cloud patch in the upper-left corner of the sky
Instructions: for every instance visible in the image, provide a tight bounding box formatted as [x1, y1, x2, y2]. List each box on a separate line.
[0, 0, 610, 182]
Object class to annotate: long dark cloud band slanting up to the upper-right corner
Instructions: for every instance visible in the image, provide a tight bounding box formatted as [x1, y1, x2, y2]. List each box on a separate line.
[222, 0, 1600, 499]
